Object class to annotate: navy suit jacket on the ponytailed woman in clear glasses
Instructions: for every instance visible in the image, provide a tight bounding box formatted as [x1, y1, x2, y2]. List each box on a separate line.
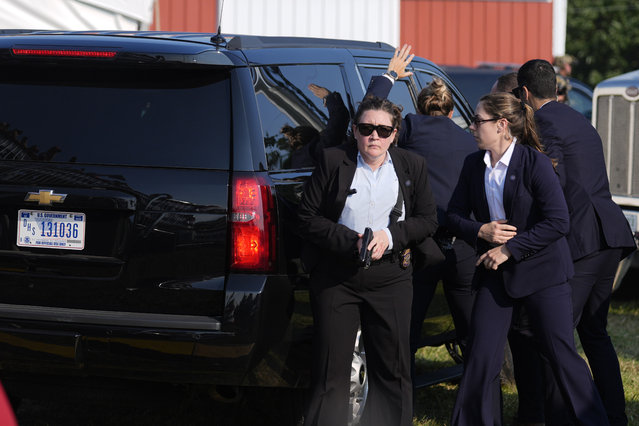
[448, 144, 573, 298]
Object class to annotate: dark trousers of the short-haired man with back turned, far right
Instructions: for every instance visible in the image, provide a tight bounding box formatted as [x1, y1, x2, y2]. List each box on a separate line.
[547, 249, 628, 426]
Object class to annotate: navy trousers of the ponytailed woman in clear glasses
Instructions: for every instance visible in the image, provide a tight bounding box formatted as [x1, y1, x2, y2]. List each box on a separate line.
[452, 272, 608, 426]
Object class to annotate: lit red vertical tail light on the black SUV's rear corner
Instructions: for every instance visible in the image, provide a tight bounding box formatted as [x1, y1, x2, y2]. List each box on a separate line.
[230, 176, 276, 272]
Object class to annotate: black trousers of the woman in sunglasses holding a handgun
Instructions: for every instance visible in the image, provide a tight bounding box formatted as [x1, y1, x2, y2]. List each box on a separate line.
[305, 256, 412, 426]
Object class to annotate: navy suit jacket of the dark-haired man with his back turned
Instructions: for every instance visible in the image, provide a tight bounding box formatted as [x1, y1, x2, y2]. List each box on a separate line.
[535, 101, 635, 260]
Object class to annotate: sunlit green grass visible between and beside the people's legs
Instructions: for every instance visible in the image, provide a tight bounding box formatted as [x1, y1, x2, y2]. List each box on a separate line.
[413, 282, 639, 426]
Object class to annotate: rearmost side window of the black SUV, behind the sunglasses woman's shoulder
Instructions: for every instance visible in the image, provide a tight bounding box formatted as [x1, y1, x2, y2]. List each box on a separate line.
[253, 65, 348, 170]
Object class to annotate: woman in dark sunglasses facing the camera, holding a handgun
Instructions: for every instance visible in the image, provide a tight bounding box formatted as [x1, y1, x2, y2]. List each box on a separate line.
[299, 97, 437, 426]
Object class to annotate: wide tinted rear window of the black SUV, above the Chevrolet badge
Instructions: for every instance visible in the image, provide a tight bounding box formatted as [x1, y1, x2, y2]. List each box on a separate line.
[0, 66, 231, 169]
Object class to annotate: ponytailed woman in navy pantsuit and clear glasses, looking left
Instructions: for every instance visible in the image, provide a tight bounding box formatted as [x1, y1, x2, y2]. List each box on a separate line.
[448, 93, 608, 426]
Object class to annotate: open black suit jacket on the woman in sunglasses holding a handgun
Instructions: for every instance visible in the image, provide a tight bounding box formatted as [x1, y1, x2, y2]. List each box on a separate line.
[299, 143, 437, 270]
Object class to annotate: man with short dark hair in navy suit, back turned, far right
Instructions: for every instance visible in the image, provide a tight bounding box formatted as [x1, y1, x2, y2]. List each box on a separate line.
[513, 59, 635, 425]
